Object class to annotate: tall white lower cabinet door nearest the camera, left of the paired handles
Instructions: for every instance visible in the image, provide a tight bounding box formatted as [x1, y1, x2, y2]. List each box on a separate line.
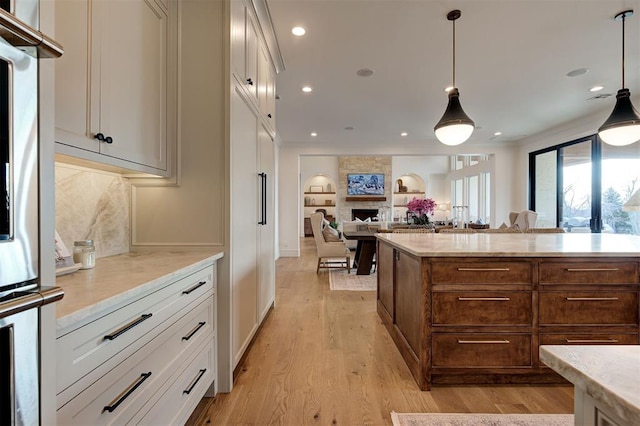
[230, 86, 260, 367]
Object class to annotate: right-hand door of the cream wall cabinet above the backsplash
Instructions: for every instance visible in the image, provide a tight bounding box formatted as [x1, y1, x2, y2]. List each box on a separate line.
[97, 0, 168, 170]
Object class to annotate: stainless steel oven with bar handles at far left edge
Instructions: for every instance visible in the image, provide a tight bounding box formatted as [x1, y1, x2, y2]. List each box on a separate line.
[0, 0, 62, 425]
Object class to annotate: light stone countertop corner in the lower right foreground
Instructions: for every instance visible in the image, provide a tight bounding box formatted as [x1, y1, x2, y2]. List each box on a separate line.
[540, 345, 640, 425]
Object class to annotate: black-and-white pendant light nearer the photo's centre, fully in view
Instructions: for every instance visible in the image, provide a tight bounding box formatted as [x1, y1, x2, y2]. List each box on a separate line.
[433, 10, 474, 146]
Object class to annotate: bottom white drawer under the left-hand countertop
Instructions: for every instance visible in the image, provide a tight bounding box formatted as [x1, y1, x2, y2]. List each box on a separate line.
[134, 343, 216, 426]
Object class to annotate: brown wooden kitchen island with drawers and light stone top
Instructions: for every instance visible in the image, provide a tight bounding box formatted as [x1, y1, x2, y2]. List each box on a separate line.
[376, 233, 640, 390]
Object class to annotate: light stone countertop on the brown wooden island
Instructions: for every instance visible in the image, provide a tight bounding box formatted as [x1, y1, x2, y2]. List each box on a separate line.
[376, 232, 640, 257]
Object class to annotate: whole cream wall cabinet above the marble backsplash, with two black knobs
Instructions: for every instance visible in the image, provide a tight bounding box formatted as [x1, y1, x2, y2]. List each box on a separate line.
[56, 0, 176, 176]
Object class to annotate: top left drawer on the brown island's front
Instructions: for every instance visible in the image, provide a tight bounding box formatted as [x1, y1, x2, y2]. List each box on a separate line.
[431, 261, 532, 284]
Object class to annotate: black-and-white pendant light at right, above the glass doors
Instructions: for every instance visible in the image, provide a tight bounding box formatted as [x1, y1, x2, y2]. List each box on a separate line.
[598, 10, 640, 146]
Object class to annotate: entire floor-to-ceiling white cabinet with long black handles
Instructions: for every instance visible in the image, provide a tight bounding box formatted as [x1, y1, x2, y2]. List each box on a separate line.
[229, 0, 275, 368]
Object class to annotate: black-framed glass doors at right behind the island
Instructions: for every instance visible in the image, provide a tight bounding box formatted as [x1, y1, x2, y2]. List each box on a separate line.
[529, 135, 640, 235]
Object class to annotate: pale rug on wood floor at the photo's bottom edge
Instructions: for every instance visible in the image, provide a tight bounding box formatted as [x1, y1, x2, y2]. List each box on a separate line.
[391, 412, 573, 426]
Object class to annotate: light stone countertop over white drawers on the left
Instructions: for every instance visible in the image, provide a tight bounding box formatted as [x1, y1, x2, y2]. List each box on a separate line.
[56, 250, 223, 332]
